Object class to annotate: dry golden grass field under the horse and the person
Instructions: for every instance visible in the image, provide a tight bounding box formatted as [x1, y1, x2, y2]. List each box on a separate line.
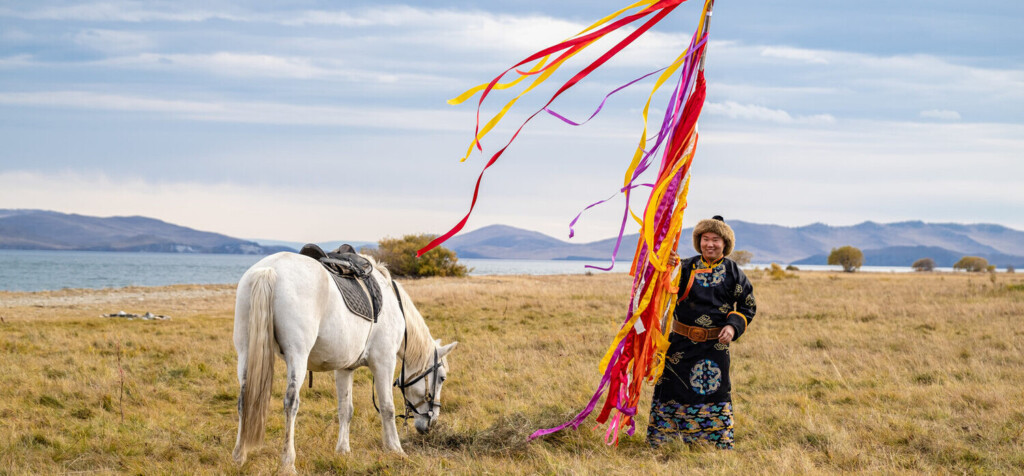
[0, 271, 1024, 475]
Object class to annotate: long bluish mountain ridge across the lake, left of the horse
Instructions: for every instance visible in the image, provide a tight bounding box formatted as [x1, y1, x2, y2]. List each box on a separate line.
[0, 210, 291, 251]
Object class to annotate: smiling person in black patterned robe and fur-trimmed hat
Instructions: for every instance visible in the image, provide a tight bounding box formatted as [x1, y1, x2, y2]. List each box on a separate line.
[647, 216, 757, 449]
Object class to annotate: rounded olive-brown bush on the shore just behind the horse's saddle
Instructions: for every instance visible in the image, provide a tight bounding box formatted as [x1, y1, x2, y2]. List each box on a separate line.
[370, 233, 469, 277]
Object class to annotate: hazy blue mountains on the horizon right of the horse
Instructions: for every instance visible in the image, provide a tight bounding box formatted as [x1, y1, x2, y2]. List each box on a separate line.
[444, 220, 1024, 267]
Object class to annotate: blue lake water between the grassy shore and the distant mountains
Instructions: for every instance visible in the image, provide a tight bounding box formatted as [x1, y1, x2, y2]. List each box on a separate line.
[0, 250, 952, 291]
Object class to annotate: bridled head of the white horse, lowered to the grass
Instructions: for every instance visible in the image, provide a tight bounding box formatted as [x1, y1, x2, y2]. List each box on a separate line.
[395, 340, 459, 433]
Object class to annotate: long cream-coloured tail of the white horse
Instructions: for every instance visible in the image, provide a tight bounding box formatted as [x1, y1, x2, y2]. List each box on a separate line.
[239, 268, 278, 451]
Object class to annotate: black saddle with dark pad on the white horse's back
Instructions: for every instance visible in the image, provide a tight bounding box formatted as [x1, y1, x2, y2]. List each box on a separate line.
[299, 244, 382, 322]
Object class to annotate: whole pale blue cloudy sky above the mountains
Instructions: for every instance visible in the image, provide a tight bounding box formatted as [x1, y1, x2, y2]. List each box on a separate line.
[0, 0, 1024, 243]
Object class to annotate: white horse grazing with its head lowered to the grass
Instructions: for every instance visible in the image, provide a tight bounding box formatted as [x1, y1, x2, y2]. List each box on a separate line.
[232, 253, 458, 472]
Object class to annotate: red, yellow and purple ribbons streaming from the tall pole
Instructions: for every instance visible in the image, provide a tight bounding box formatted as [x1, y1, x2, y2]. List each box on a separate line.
[418, 0, 714, 444]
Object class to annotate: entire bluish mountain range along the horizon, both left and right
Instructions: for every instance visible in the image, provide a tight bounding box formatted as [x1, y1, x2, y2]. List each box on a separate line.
[6, 209, 1024, 268]
